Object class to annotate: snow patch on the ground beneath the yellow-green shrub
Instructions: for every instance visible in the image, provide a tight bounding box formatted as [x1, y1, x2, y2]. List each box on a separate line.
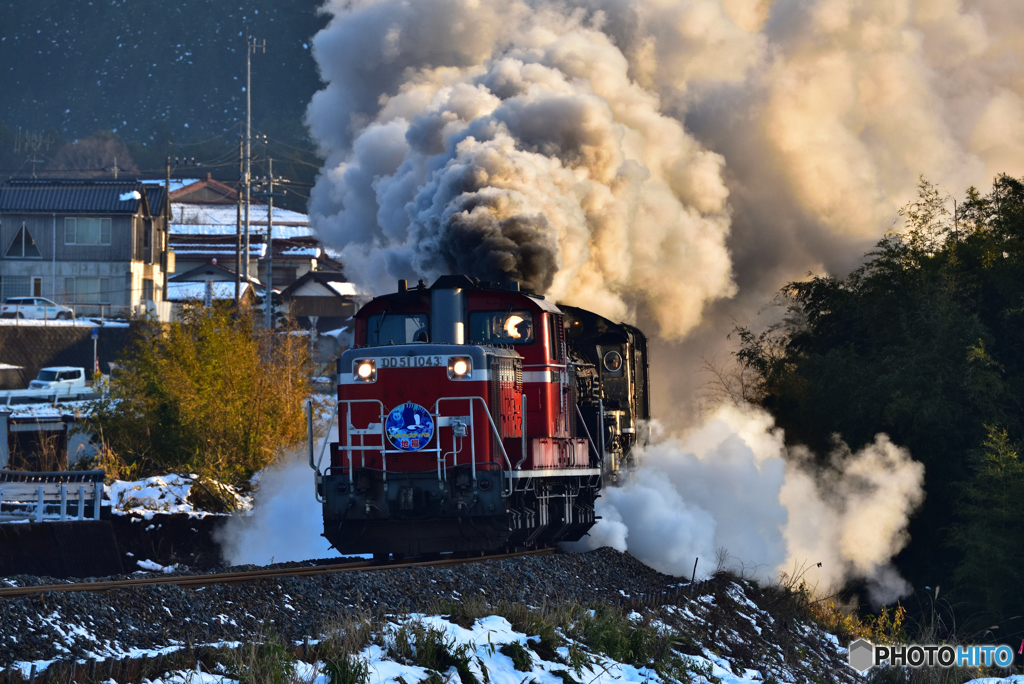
[103, 474, 252, 520]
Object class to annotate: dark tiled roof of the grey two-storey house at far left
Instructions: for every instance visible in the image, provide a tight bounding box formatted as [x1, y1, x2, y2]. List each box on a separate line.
[0, 178, 165, 216]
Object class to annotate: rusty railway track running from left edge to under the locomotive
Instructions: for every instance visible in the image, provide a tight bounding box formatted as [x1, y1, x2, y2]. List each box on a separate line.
[0, 549, 555, 598]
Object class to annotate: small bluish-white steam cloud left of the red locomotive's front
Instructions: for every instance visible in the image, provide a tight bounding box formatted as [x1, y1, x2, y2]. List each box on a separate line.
[216, 454, 338, 565]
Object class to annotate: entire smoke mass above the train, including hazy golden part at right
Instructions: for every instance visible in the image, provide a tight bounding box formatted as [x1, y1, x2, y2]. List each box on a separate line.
[307, 0, 1024, 346]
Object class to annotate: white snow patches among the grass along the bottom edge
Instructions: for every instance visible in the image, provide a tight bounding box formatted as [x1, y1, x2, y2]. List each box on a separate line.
[13, 614, 782, 684]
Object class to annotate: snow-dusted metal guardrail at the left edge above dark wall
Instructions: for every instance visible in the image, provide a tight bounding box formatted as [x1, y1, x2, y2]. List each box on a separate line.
[0, 470, 105, 522]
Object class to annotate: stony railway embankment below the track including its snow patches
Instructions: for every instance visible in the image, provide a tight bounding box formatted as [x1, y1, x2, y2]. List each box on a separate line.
[0, 549, 855, 684]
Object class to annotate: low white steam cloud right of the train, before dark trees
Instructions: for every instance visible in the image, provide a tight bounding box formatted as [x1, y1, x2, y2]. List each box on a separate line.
[583, 404, 925, 604]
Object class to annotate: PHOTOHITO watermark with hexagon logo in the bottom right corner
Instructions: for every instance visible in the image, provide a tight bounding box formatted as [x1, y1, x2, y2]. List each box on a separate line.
[850, 639, 1014, 673]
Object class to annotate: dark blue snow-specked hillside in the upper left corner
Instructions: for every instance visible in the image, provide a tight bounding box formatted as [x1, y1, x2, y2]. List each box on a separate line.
[0, 0, 326, 145]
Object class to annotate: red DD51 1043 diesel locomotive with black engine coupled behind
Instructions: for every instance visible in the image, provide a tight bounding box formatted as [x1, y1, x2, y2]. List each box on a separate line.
[316, 275, 649, 556]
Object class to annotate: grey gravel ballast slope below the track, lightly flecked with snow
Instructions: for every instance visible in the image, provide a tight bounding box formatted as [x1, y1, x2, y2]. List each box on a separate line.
[0, 549, 846, 681]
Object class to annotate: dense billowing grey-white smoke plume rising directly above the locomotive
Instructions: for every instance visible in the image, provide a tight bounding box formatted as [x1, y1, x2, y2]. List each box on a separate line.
[308, 0, 734, 337]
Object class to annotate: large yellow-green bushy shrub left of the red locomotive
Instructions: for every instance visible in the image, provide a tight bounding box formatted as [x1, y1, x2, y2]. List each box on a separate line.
[90, 305, 311, 497]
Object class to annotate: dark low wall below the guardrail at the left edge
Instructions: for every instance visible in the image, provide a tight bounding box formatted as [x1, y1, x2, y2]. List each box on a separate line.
[0, 520, 124, 579]
